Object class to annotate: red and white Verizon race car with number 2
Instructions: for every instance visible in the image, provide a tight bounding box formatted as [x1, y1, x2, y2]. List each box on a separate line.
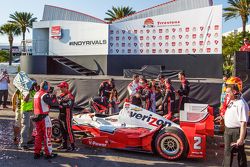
[52, 103, 214, 160]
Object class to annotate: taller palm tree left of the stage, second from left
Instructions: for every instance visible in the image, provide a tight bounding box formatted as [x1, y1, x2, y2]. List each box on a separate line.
[9, 12, 37, 52]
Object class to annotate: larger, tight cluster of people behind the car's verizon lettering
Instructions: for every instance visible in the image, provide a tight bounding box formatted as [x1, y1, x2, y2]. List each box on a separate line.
[127, 72, 190, 119]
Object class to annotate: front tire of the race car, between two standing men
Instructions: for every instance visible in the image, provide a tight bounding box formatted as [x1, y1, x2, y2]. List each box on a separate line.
[51, 119, 62, 142]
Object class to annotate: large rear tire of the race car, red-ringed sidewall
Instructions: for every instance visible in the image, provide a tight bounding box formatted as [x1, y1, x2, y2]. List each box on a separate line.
[154, 127, 188, 160]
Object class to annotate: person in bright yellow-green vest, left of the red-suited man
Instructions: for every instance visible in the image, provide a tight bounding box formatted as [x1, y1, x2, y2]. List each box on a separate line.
[19, 82, 37, 150]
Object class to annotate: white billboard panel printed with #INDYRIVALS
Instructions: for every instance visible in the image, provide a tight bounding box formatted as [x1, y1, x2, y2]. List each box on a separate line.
[45, 20, 108, 56]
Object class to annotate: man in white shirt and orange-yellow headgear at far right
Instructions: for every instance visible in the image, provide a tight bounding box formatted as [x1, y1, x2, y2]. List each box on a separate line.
[223, 77, 249, 167]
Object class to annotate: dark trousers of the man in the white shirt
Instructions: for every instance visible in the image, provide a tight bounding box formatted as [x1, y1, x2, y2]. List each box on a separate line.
[223, 127, 247, 167]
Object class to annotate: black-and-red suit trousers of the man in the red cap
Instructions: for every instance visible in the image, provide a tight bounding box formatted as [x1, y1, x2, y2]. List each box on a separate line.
[59, 109, 75, 147]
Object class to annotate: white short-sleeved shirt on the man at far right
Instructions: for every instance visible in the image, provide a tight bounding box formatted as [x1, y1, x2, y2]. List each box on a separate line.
[224, 98, 249, 128]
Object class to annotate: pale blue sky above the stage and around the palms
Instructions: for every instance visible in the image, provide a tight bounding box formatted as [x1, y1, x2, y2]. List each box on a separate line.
[0, 0, 241, 45]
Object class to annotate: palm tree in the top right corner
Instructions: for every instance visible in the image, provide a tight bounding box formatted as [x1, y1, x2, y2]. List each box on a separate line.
[223, 0, 250, 38]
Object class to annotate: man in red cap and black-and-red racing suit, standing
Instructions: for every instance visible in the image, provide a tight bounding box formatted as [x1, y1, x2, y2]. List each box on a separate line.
[57, 81, 75, 151]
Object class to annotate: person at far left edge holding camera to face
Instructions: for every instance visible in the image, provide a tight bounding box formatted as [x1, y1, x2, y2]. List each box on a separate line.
[0, 69, 10, 108]
